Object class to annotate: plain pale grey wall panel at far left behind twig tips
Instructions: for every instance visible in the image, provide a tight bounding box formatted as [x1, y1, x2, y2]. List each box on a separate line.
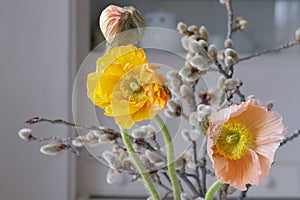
[0, 0, 71, 200]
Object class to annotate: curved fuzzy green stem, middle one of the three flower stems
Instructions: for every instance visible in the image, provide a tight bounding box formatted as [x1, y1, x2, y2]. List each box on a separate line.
[154, 114, 180, 200]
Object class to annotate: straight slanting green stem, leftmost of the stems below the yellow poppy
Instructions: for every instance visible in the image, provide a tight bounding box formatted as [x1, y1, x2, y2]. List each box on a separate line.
[120, 127, 160, 200]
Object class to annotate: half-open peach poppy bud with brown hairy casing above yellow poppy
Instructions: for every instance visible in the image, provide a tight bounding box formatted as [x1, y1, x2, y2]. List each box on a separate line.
[99, 5, 146, 46]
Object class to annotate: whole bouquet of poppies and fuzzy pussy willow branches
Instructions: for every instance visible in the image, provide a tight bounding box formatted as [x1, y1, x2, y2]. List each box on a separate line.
[18, 0, 300, 200]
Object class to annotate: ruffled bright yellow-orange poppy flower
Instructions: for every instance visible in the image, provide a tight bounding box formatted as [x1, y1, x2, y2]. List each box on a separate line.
[87, 45, 169, 129]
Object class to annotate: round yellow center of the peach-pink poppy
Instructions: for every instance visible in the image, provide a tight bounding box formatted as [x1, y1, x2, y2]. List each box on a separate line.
[216, 120, 253, 160]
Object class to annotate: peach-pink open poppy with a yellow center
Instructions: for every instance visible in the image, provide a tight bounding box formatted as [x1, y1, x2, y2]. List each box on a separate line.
[207, 99, 286, 190]
